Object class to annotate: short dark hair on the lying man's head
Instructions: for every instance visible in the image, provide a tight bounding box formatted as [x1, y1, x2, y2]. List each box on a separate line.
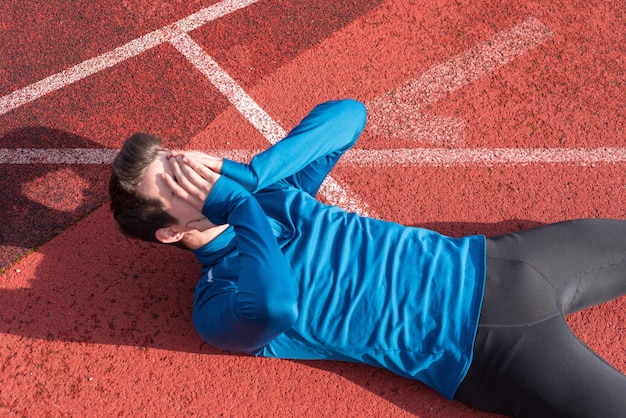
[109, 132, 177, 242]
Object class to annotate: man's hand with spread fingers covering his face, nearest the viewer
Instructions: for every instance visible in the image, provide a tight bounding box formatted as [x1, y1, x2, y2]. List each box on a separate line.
[162, 151, 221, 212]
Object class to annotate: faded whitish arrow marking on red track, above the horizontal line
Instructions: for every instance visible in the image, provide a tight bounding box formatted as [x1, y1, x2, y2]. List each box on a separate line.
[367, 17, 554, 147]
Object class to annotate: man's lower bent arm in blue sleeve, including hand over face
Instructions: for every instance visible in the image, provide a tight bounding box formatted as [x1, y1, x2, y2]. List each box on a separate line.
[163, 154, 297, 352]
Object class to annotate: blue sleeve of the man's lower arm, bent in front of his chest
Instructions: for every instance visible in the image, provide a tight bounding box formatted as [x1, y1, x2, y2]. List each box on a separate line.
[193, 176, 298, 353]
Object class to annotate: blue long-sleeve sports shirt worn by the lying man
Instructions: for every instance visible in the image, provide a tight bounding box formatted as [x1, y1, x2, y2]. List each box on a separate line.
[193, 100, 485, 398]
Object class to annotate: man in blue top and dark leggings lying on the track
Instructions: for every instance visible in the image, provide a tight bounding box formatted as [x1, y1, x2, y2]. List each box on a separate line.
[110, 100, 626, 417]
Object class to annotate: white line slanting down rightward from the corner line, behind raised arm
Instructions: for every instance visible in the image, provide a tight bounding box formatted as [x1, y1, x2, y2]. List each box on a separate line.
[170, 34, 372, 216]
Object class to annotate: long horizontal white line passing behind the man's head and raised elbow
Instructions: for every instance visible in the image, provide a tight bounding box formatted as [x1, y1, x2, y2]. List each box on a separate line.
[0, 147, 626, 167]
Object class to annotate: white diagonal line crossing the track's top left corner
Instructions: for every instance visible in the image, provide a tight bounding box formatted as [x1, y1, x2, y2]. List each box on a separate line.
[0, 0, 258, 116]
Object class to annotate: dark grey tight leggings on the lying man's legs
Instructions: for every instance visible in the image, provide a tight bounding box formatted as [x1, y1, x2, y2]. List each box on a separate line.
[455, 219, 626, 418]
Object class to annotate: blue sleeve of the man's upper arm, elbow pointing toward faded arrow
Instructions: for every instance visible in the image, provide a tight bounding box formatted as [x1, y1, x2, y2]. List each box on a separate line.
[222, 99, 365, 195]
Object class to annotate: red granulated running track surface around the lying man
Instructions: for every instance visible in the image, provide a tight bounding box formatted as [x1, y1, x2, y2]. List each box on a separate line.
[0, 0, 626, 418]
